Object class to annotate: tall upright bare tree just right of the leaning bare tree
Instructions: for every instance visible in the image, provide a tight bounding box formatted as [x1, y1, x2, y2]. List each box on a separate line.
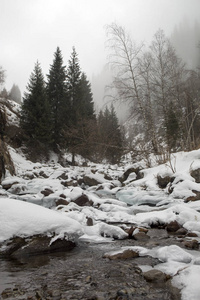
[150, 30, 186, 151]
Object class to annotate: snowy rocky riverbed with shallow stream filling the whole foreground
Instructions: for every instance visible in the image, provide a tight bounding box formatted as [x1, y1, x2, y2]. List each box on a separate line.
[0, 149, 200, 300]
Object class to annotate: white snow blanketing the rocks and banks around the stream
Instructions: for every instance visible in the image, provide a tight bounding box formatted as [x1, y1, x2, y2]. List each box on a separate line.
[0, 148, 200, 300]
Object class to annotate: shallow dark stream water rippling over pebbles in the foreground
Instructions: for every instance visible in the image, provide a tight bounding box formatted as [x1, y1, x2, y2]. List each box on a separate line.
[0, 229, 184, 300]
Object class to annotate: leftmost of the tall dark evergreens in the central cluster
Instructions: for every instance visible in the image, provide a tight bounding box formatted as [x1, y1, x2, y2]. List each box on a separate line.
[21, 62, 51, 146]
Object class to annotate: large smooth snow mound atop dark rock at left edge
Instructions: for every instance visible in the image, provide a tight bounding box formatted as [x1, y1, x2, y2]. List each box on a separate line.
[0, 198, 82, 242]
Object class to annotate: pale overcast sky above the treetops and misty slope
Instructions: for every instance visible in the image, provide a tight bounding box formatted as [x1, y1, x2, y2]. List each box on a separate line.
[0, 0, 200, 93]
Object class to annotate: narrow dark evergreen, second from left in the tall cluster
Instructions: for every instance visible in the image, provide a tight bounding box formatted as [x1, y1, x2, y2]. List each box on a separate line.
[47, 47, 69, 146]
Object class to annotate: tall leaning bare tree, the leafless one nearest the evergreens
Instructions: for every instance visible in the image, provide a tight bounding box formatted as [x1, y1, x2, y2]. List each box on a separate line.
[107, 23, 162, 152]
